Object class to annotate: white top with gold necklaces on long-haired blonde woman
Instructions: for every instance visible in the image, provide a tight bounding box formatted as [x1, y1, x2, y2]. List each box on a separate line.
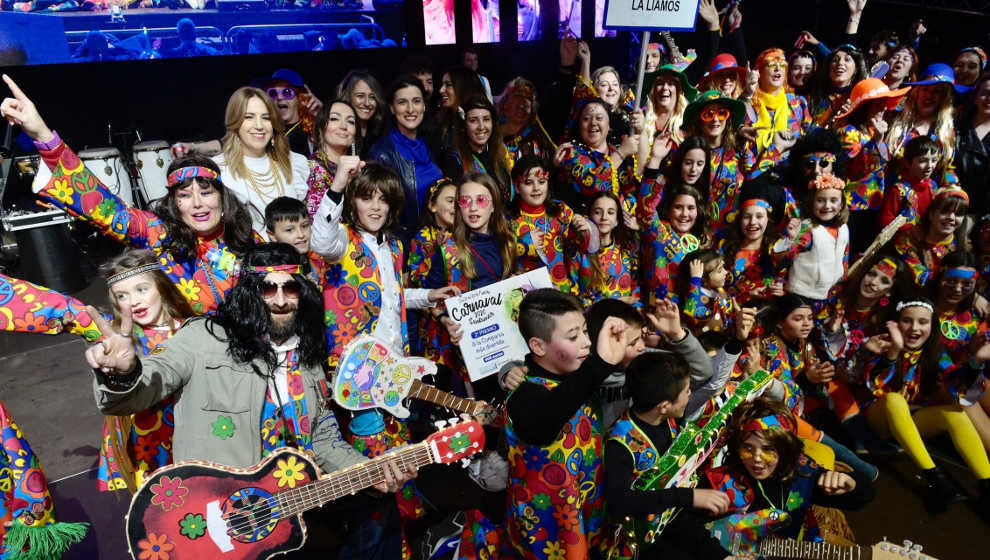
[213, 152, 309, 239]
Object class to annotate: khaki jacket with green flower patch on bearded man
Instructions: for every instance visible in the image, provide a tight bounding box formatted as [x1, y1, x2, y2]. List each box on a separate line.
[93, 319, 366, 473]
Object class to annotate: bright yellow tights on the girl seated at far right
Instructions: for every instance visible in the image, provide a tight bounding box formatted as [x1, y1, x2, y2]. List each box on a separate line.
[866, 393, 990, 480]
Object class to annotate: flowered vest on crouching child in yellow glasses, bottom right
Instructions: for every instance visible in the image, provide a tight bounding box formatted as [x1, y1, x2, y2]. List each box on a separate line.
[707, 453, 822, 552]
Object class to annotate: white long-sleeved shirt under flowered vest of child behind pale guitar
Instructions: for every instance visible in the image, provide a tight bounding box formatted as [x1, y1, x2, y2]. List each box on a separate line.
[310, 192, 433, 350]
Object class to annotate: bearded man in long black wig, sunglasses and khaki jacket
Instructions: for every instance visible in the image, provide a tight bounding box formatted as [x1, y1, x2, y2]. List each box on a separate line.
[86, 243, 416, 558]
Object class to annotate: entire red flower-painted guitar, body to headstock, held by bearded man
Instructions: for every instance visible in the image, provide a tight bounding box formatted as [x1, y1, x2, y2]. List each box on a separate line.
[127, 421, 485, 560]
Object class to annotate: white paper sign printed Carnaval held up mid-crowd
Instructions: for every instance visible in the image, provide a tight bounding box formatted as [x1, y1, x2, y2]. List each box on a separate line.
[446, 267, 553, 381]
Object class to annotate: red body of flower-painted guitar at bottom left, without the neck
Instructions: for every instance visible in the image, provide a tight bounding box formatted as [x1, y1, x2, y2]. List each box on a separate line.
[127, 449, 319, 560]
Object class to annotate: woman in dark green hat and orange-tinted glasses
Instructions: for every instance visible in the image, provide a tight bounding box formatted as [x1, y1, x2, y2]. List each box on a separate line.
[680, 91, 794, 234]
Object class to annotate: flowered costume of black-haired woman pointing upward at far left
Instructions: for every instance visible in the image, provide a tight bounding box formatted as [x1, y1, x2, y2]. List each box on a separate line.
[38, 142, 248, 315]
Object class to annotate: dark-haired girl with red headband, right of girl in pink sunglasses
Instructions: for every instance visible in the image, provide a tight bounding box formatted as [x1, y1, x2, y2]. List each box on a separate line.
[509, 156, 601, 295]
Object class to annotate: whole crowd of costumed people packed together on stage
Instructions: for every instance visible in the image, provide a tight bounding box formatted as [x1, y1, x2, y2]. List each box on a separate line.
[0, 0, 990, 560]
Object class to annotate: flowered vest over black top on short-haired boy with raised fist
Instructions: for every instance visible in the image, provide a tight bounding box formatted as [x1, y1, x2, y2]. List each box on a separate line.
[505, 377, 604, 560]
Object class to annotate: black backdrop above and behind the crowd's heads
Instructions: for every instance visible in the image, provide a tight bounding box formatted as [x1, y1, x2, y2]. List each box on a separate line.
[4, 0, 990, 149]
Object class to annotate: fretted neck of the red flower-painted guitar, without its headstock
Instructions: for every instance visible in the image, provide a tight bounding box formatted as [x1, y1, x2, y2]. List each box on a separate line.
[276, 441, 437, 517]
